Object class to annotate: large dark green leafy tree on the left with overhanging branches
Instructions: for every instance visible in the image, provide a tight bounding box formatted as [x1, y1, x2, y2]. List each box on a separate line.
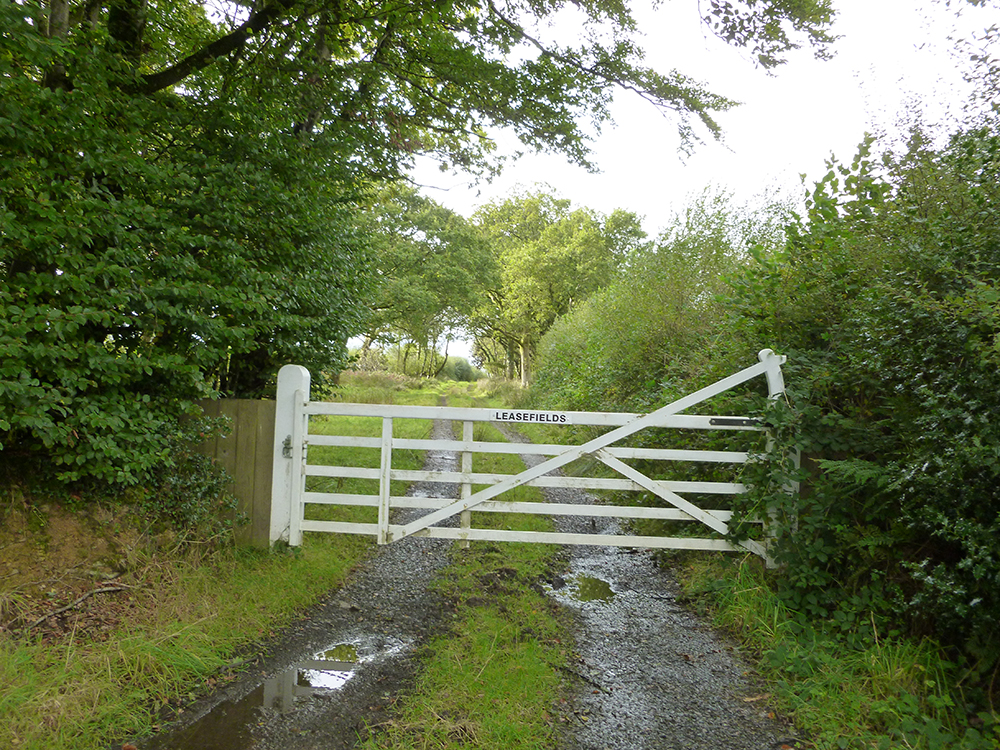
[0, 0, 831, 482]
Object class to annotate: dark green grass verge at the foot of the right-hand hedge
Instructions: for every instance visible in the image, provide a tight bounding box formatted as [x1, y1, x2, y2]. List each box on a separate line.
[678, 555, 1000, 750]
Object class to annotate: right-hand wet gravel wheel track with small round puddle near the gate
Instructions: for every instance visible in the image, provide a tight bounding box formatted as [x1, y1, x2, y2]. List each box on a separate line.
[502, 428, 796, 750]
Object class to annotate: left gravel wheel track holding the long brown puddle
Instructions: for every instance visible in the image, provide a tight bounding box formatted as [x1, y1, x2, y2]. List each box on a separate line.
[135, 422, 458, 750]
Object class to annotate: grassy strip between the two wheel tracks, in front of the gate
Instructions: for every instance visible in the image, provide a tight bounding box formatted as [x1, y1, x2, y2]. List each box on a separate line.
[362, 568, 567, 750]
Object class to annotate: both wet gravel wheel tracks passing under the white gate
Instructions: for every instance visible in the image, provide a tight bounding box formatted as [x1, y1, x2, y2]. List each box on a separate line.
[136, 424, 796, 750]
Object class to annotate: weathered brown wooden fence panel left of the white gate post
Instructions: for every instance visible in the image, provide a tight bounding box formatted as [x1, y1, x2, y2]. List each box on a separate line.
[199, 399, 275, 547]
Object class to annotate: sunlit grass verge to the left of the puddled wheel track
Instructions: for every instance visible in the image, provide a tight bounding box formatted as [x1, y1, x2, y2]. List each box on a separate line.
[0, 537, 368, 750]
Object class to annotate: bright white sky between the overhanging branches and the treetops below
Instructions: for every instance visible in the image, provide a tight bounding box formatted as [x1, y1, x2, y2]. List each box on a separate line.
[414, 0, 1000, 234]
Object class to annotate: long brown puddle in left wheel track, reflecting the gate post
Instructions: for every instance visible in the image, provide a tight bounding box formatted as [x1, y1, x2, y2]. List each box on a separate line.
[142, 642, 406, 750]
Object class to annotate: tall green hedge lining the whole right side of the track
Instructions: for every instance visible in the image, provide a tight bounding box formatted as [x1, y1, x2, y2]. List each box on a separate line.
[531, 124, 1000, 692]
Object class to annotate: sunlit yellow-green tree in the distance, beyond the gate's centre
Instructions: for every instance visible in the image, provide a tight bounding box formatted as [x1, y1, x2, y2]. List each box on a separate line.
[472, 191, 645, 385]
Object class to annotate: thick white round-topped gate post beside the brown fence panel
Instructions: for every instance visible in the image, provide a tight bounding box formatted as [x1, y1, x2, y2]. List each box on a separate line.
[269, 365, 311, 544]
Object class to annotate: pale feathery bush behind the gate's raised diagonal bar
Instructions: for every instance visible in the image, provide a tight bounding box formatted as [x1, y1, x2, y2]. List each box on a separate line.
[535, 189, 787, 411]
